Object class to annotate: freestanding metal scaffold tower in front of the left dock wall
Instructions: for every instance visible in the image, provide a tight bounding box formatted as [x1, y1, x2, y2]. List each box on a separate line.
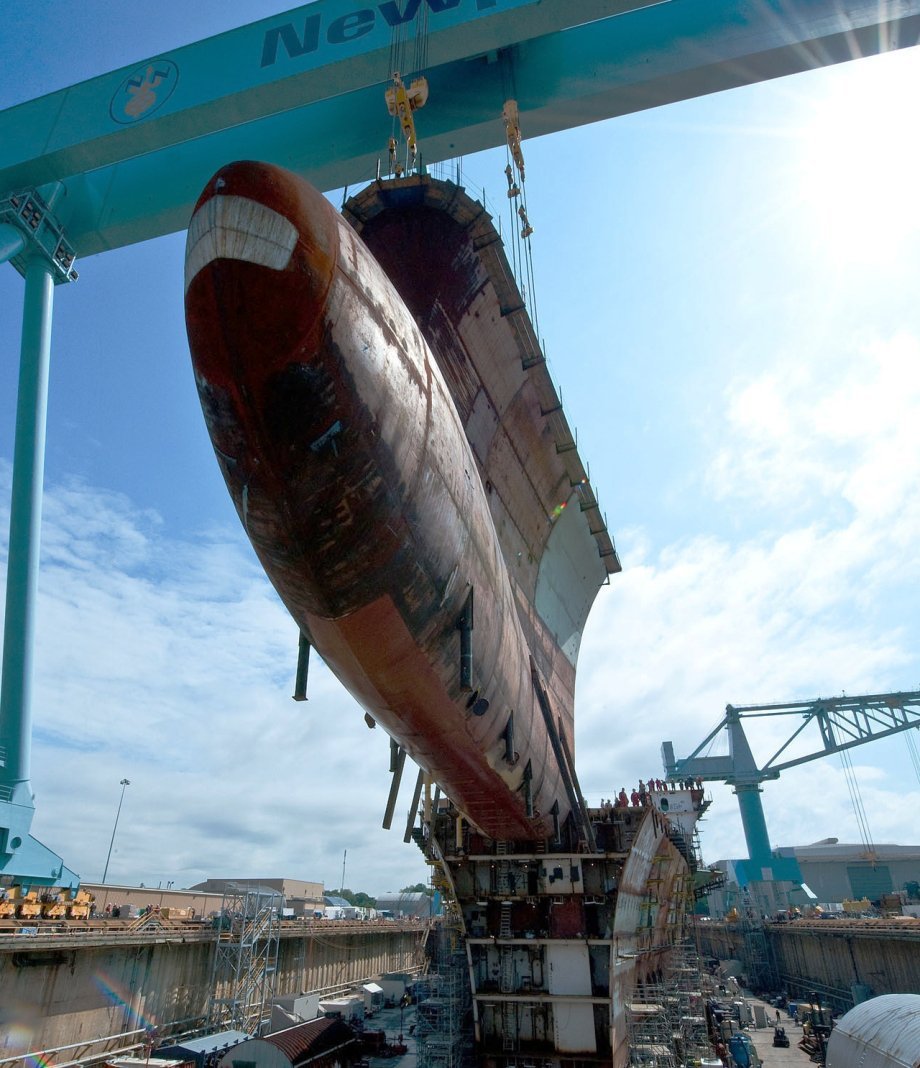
[208, 883, 284, 1035]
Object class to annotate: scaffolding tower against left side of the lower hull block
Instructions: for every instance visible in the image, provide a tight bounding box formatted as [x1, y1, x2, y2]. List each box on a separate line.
[416, 926, 472, 1068]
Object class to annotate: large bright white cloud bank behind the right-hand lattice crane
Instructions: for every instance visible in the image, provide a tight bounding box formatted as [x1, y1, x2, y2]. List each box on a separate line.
[576, 335, 920, 859]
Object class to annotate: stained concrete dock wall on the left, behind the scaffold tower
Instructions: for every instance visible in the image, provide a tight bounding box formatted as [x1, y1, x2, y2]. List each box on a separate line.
[0, 922, 426, 1063]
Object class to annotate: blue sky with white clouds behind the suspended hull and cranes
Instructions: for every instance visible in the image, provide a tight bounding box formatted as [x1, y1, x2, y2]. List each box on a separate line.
[0, 0, 920, 893]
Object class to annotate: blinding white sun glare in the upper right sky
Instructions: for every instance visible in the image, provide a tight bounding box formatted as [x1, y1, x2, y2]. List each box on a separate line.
[797, 47, 920, 264]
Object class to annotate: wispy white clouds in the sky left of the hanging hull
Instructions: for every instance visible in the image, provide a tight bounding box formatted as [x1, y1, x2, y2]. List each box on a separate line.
[0, 468, 426, 893]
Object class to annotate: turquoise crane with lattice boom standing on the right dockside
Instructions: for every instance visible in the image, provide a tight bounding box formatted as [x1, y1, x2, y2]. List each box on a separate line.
[661, 690, 920, 881]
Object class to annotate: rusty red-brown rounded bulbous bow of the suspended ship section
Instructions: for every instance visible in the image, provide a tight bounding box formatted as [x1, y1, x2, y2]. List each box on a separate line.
[186, 162, 619, 841]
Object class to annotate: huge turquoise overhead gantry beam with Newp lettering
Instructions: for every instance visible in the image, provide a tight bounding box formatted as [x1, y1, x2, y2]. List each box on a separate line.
[0, 0, 920, 255]
